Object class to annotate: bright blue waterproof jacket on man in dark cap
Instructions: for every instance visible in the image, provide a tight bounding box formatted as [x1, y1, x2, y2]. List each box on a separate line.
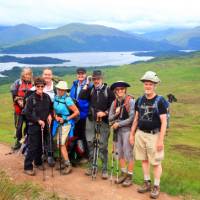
[70, 80, 92, 119]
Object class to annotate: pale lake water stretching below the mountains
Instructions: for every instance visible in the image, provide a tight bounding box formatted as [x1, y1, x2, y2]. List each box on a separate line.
[0, 51, 153, 75]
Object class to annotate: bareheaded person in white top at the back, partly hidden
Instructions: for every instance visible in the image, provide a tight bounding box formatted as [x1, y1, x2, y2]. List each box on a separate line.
[42, 68, 56, 166]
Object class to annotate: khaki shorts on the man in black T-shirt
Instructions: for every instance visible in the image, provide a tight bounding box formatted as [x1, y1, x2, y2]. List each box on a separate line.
[134, 130, 164, 165]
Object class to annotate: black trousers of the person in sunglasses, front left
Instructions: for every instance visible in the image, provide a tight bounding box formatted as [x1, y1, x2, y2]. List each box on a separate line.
[24, 125, 46, 170]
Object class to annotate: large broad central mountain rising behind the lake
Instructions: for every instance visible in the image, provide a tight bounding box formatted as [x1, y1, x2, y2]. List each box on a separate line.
[1, 23, 177, 53]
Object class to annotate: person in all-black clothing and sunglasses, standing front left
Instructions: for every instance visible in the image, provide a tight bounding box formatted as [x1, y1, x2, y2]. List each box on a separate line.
[24, 77, 52, 176]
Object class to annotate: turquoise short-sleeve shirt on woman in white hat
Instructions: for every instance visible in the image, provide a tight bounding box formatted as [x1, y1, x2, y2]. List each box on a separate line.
[53, 94, 74, 123]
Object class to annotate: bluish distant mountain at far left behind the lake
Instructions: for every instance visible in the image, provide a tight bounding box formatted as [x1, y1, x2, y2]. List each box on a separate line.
[0, 24, 44, 46]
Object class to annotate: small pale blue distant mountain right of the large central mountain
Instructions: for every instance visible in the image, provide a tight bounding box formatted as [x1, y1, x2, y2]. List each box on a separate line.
[142, 28, 187, 41]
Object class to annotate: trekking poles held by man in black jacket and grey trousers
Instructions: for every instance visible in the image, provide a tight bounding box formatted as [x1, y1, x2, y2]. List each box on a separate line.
[92, 117, 101, 180]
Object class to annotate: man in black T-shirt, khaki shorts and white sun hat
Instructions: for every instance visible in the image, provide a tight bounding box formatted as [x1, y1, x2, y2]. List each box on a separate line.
[130, 71, 167, 198]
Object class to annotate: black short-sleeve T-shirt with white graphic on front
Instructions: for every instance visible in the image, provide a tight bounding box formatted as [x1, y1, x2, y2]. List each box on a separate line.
[135, 95, 167, 131]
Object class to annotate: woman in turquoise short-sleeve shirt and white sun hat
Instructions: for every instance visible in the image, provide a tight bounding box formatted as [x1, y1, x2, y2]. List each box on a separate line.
[53, 81, 79, 175]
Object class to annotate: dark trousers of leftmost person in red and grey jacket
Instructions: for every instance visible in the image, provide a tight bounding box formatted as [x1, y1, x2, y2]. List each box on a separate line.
[15, 114, 27, 141]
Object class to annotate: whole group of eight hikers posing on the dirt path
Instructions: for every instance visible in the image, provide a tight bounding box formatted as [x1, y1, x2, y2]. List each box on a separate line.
[11, 68, 168, 198]
